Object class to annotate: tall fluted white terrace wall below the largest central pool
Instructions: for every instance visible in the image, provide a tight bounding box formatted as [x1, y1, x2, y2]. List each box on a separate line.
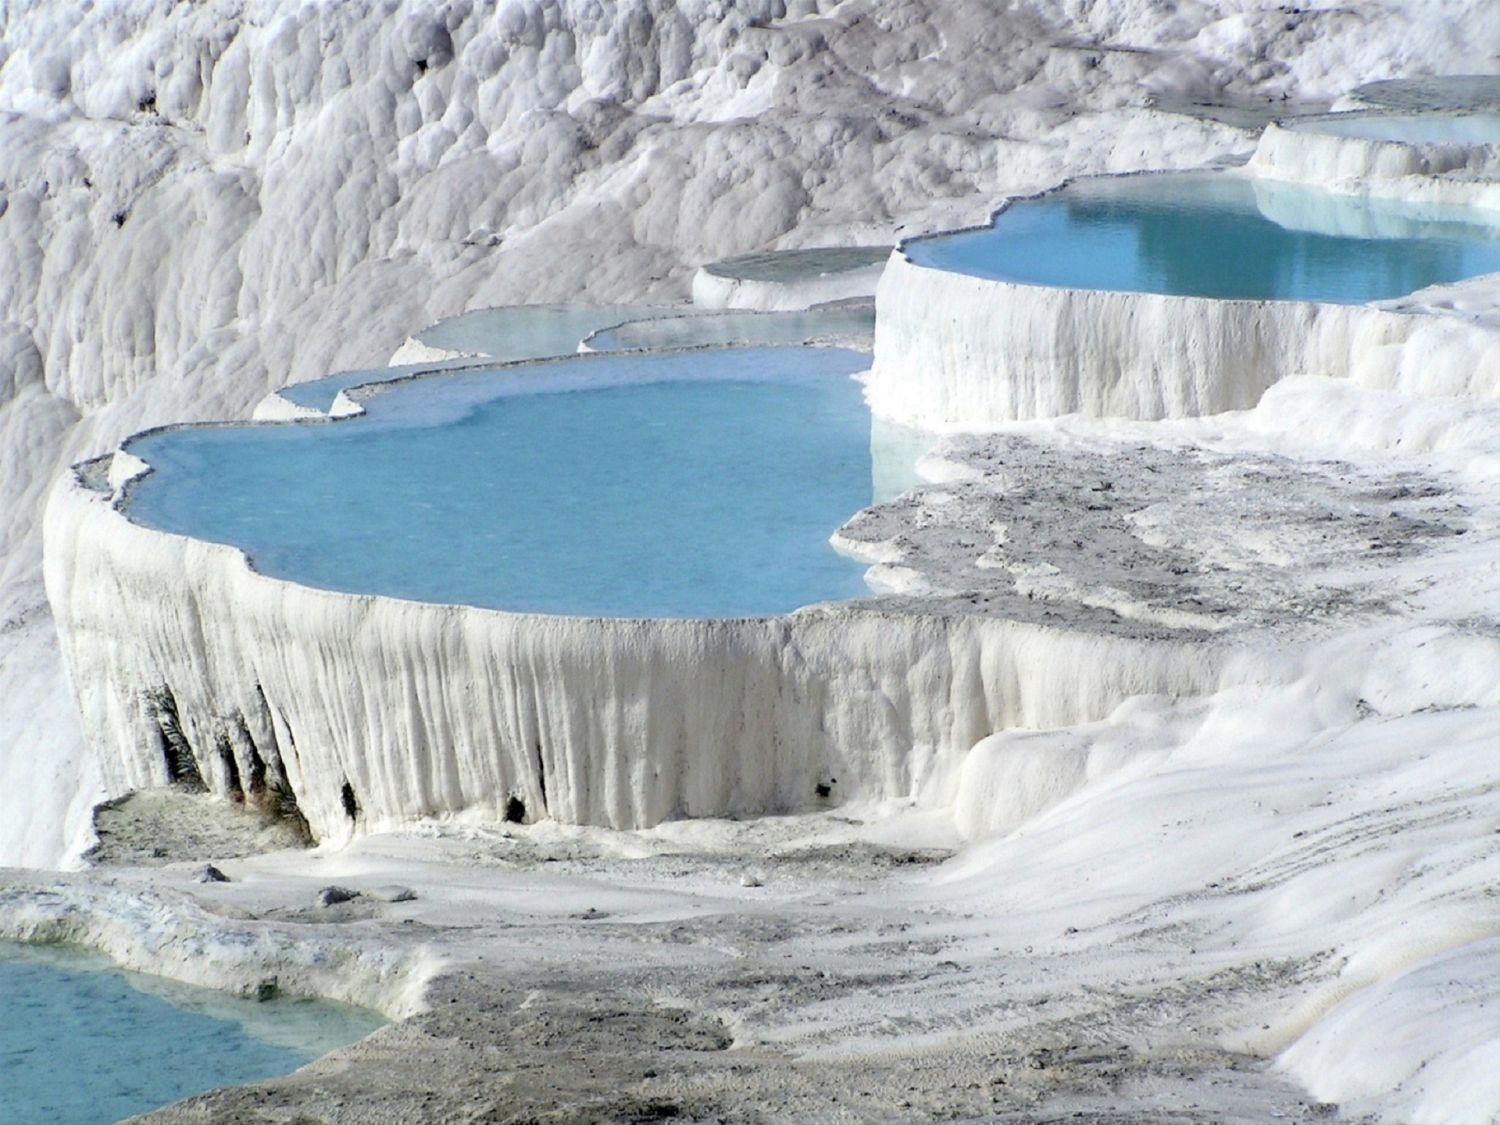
[47, 459, 1260, 839]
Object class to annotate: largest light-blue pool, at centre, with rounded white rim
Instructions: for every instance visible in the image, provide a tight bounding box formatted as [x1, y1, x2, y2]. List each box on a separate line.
[128, 348, 872, 618]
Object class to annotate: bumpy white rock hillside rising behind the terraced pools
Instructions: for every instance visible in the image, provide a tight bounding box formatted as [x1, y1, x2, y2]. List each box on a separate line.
[0, 0, 1487, 863]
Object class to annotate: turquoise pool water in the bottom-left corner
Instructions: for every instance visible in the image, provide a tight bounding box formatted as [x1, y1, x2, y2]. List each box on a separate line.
[0, 942, 384, 1125]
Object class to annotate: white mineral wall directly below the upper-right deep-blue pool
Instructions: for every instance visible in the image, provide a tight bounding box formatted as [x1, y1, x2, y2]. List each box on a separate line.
[867, 249, 1500, 429]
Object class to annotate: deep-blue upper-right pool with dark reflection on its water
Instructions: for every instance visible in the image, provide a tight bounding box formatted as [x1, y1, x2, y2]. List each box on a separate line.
[906, 173, 1500, 305]
